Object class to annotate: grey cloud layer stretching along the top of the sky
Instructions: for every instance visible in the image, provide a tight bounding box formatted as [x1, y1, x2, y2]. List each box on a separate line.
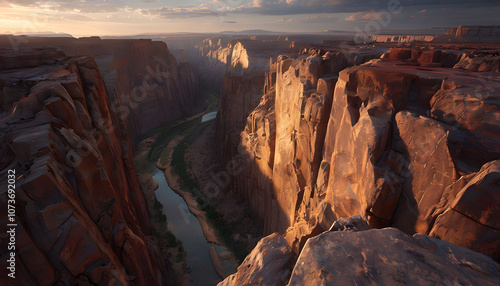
[3, 0, 498, 18]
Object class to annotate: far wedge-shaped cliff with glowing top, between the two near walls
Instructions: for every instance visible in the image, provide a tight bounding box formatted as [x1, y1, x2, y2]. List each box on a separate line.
[214, 40, 297, 161]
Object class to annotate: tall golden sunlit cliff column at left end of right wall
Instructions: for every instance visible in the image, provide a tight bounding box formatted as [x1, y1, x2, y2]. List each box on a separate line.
[234, 49, 383, 239]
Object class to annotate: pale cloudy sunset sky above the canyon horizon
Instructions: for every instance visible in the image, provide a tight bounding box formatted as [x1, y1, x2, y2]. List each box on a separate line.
[0, 0, 500, 36]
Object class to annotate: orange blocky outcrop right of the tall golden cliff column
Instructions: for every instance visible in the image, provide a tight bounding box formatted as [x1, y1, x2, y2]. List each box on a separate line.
[298, 52, 500, 258]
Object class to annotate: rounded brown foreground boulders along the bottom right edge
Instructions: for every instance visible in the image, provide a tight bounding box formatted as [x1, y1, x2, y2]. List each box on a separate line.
[219, 216, 500, 286]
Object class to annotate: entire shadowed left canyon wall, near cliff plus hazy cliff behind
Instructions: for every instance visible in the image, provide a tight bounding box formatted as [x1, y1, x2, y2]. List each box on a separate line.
[0, 38, 198, 285]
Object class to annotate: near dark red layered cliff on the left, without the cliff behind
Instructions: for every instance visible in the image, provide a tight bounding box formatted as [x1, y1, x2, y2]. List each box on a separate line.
[0, 50, 169, 285]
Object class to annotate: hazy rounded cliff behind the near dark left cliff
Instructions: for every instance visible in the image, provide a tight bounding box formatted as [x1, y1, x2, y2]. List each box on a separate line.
[0, 37, 199, 140]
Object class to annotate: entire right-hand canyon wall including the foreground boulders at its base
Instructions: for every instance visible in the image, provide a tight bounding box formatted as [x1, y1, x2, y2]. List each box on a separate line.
[219, 41, 500, 285]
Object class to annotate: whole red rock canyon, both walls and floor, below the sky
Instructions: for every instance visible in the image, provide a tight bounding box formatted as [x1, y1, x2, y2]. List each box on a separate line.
[0, 26, 500, 285]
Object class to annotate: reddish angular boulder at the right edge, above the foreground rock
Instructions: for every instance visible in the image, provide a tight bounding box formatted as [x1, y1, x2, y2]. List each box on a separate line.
[429, 160, 500, 261]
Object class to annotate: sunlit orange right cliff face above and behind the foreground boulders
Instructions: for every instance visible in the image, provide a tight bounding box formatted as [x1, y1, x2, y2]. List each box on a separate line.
[228, 43, 500, 260]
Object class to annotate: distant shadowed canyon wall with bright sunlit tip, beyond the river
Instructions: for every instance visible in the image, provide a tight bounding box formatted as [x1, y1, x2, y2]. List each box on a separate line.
[195, 38, 299, 161]
